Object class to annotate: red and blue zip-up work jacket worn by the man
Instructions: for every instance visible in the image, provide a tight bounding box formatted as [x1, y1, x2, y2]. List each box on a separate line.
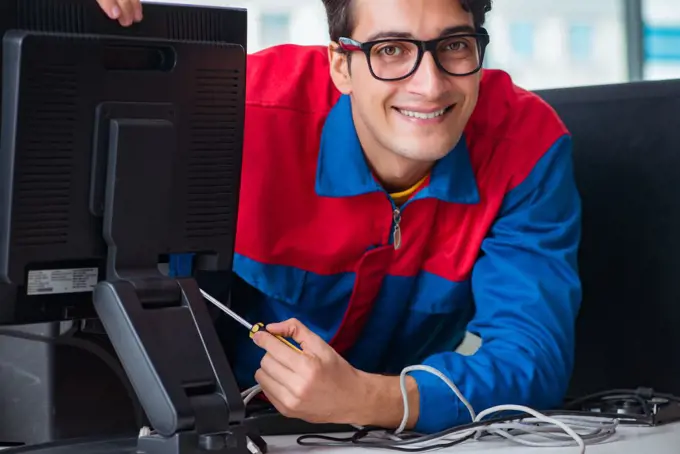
[171, 45, 581, 432]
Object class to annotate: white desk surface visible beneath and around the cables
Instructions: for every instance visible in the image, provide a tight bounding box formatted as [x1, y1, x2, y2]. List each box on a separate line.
[265, 423, 680, 454]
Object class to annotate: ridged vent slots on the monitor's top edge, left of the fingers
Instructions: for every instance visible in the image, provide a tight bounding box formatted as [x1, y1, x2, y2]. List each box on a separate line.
[19, 0, 87, 33]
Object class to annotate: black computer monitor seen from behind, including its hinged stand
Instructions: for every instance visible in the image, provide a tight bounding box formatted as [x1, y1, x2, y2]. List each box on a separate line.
[0, 0, 255, 454]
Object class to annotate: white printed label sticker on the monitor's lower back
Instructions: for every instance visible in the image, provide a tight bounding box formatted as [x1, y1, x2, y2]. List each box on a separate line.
[26, 268, 99, 295]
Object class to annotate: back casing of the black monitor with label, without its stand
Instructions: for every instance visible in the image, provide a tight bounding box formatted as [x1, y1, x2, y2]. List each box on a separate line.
[0, 0, 246, 324]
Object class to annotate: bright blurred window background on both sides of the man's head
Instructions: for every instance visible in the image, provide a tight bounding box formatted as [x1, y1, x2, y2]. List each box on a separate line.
[150, 0, 680, 90]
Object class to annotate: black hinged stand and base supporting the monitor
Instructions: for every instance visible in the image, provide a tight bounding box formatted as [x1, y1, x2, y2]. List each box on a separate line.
[25, 103, 266, 454]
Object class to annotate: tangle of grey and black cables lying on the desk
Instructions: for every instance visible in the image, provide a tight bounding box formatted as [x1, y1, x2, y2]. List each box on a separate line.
[241, 365, 619, 454]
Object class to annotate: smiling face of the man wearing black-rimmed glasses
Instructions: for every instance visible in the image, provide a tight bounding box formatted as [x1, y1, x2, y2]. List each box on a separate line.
[331, 0, 481, 163]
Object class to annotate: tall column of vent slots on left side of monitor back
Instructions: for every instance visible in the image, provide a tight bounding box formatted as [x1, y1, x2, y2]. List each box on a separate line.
[12, 65, 78, 246]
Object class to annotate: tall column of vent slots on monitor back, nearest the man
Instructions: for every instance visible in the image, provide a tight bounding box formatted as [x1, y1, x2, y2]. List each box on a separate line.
[186, 70, 240, 239]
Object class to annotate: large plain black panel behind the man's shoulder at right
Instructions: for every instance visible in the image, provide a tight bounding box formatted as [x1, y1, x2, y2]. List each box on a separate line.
[537, 80, 680, 396]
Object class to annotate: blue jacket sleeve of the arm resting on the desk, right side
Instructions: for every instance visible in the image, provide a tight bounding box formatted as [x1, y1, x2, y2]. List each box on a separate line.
[412, 136, 581, 433]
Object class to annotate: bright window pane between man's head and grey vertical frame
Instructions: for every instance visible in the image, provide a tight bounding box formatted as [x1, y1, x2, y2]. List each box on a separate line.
[485, 0, 628, 90]
